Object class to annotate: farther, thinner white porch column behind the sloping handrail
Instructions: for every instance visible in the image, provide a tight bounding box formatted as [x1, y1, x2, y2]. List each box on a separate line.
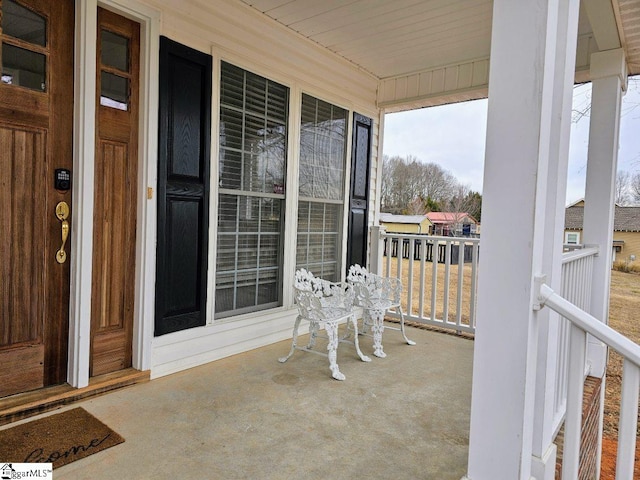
[583, 49, 627, 377]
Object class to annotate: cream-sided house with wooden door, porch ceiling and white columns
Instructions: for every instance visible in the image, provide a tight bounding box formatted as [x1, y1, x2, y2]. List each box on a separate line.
[0, 0, 640, 480]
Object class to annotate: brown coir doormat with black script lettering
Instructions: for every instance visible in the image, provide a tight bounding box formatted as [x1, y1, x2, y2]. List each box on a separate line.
[0, 408, 124, 468]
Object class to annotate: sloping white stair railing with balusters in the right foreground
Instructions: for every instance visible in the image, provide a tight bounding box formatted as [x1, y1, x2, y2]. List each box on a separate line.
[538, 278, 640, 480]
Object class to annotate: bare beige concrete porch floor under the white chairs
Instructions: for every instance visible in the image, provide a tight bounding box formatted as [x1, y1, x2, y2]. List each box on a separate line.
[15, 327, 473, 480]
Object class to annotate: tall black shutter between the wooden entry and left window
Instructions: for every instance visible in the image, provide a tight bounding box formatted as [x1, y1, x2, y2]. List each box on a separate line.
[155, 37, 212, 336]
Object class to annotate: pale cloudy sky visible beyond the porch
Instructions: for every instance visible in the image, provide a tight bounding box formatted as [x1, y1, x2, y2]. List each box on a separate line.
[383, 77, 640, 205]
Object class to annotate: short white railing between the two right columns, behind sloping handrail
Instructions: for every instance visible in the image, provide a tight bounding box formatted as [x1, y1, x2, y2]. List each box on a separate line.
[553, 247, 598, 436]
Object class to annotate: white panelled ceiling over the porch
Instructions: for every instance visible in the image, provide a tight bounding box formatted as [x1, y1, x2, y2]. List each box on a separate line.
[241, 0, 640, 79]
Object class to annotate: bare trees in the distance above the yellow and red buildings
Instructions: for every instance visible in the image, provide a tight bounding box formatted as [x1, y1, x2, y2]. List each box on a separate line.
[381, 155, 482, 222]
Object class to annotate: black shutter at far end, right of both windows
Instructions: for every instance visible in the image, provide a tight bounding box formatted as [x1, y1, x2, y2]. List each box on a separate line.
[347, 113, 373, 269]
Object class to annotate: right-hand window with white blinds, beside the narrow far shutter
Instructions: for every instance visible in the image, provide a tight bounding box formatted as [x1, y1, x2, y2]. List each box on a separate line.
[296, 95, 348, 281]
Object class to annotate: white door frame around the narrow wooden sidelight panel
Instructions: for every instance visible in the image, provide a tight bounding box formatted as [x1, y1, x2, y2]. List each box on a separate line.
[67, 0, 160, 388]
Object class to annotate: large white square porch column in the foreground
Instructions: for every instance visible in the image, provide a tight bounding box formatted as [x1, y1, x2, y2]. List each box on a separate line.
[467, 0, 578, 480]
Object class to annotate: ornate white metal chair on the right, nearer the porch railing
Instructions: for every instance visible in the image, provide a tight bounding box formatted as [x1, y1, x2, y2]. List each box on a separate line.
[347, 265, 416, 358]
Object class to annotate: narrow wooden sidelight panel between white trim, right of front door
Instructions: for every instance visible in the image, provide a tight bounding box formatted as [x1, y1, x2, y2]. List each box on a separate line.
[90, 8, 140, 376]
